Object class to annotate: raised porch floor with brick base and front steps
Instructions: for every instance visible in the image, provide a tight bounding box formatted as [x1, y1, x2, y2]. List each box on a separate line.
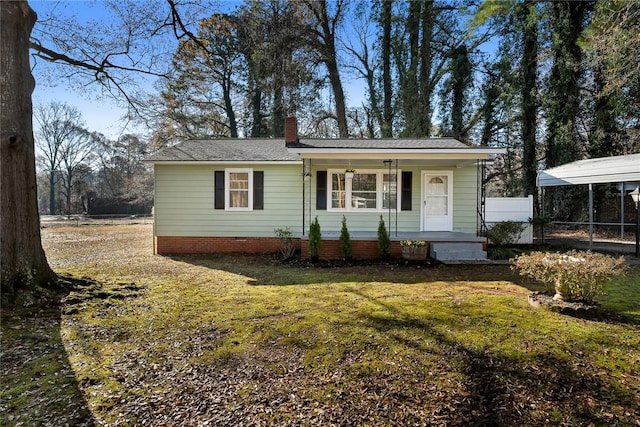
[300, 231, 487, 262]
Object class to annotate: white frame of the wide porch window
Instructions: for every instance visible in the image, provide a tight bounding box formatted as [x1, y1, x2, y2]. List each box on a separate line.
[327, 169, 402, 212]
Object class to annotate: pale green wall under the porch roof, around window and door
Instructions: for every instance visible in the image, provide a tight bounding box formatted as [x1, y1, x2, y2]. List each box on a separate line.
[304, 164, 478, 234]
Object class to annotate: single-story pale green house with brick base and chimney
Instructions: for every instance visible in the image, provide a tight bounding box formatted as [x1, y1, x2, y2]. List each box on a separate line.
[148, 117, 505, 259]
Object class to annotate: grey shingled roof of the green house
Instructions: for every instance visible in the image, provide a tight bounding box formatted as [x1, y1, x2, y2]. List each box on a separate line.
[148, 138, 478, 162]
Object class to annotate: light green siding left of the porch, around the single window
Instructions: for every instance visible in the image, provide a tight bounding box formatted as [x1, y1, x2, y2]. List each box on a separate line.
[154, 164, 302, 237]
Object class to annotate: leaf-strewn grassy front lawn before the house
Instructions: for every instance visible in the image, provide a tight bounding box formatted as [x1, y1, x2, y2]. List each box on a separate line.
[0, 226, 640, 425]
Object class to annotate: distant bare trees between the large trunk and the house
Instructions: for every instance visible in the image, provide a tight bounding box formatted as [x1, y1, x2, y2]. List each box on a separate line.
[34, 101, 153, 215]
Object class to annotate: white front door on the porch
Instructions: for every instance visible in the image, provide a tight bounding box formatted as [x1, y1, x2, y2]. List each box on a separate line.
[422, 172, 453, 231]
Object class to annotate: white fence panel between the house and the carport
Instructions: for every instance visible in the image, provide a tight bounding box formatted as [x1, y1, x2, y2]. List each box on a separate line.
[485, 196, 533, 244]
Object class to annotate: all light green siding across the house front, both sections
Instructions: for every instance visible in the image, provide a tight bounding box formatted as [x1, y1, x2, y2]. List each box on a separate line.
[154, 164, 477, 237]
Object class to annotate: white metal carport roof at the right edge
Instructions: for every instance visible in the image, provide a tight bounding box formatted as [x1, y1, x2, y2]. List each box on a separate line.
[536, 153, 640, 187]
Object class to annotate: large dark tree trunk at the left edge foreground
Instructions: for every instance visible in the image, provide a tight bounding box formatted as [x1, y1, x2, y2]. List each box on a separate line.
[0, 1, 55, 303]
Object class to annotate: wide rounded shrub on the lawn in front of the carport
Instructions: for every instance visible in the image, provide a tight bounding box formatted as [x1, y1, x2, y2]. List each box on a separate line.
[514, 250, 626, 303]
